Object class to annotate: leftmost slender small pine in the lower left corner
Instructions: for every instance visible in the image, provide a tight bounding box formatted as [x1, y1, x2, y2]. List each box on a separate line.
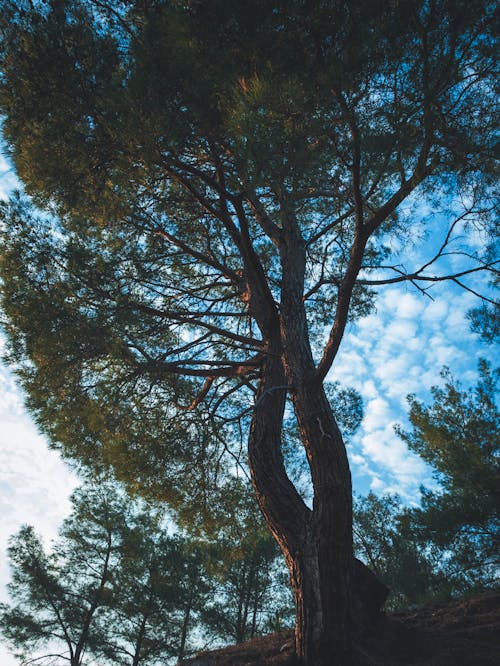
[0, 487, 127, 666]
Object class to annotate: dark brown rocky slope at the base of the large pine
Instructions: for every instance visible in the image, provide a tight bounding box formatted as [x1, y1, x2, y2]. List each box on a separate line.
[186, 590, 500, 666]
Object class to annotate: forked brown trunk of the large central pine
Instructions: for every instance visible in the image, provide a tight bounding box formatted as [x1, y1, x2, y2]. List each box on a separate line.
[249, 226, 385, 666]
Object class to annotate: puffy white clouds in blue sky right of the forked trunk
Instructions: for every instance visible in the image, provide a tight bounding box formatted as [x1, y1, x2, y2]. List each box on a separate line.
[331, 278, 494, 503]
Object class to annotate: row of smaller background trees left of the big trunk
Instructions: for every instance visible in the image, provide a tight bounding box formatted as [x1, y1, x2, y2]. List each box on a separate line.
[0, 480, 293, 666]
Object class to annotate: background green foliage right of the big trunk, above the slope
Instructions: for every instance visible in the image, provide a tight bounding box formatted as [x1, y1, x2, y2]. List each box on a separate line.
[354, 361, 500, 608]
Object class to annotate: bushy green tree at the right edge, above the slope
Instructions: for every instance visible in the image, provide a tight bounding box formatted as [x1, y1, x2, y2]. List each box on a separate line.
[398, 361, 500, 589]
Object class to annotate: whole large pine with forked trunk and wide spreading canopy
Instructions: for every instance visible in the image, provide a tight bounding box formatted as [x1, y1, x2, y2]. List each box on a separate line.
[0, 0, 496, 666]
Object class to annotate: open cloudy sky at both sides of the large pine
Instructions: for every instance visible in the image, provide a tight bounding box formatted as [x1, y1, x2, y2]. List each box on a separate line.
[0, 152, 494, 666]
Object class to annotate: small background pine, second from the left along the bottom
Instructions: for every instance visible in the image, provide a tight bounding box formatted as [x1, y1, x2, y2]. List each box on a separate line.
[94, 528, 211, 666]
